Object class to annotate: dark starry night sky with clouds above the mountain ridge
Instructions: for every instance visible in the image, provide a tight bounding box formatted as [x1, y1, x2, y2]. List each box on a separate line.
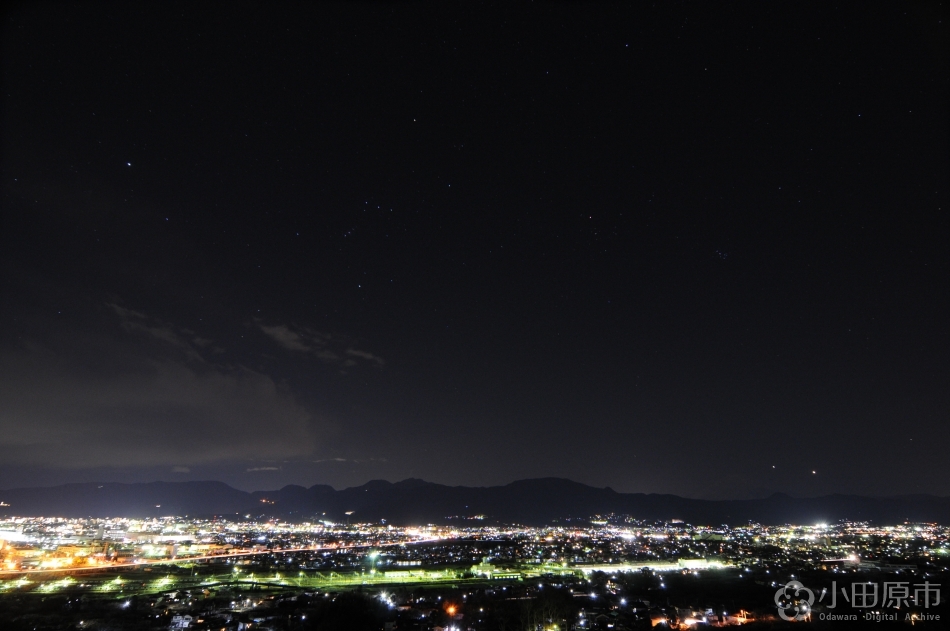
[0, 2, 950, 498]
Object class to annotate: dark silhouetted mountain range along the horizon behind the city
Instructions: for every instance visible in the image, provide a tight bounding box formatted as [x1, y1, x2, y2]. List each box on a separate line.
[0, 478, 950, 526]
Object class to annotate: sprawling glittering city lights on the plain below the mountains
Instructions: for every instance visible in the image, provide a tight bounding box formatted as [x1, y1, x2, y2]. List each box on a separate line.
[0, 515, 950, 630]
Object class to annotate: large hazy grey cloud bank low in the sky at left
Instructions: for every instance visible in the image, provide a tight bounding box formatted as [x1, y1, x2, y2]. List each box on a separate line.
[0, 304, 316, 473]
